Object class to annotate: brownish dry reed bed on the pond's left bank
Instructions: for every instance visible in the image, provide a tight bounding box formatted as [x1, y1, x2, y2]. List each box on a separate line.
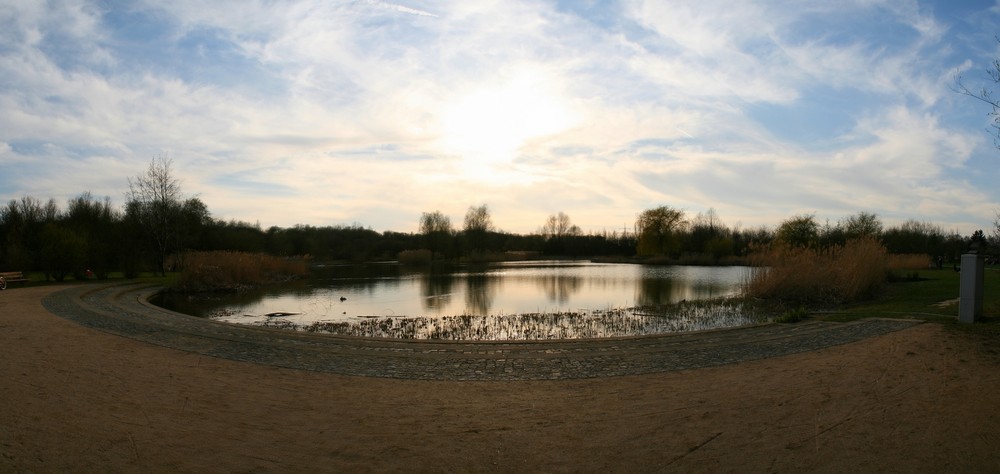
[175, 251, 308, 291]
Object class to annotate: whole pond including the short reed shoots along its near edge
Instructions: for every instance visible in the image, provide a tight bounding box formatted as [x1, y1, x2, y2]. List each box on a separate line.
[154, 260, 752, 339]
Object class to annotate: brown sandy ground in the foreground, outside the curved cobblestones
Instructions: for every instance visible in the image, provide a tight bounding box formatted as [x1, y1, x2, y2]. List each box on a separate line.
[0, 287, 1000, 473]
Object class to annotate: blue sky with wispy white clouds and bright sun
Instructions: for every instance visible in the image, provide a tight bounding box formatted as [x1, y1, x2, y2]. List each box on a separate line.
[0, 0, 1000, 235]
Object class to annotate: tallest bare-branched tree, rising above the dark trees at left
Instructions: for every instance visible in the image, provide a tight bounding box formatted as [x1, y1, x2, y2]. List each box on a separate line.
[126, 156, 182, 275]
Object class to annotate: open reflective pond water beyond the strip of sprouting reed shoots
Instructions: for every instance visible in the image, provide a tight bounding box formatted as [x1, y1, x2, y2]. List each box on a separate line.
[157, 261, 746, 336]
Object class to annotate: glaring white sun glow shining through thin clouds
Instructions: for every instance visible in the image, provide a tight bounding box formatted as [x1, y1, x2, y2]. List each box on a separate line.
[442, 70, 575, 174]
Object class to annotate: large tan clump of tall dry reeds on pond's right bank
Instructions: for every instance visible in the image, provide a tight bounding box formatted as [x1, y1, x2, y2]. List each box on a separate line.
[744, 239, 888, 304]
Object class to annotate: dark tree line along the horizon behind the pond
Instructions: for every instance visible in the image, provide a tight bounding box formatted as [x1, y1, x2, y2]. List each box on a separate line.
[0, 158, 1000, 281]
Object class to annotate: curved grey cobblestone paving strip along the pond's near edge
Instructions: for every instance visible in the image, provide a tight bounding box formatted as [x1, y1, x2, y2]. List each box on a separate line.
[42, 284, 918, 380]
